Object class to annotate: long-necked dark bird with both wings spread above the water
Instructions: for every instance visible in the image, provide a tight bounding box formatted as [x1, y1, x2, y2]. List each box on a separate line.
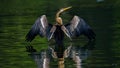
[26, 6, 96, 44]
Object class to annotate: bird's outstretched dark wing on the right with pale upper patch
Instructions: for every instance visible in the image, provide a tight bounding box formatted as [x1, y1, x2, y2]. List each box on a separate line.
[65, 16, 95, 40]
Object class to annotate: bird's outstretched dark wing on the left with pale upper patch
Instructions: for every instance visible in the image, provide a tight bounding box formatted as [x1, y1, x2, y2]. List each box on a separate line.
[26, 15, 52, 42]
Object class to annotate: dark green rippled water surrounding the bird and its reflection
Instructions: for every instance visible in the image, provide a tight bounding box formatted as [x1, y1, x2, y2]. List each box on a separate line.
[0, 0, 120, 68]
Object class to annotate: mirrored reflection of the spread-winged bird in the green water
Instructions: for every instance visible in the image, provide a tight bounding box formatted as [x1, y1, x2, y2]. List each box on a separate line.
[26, 40, 95, 68]
